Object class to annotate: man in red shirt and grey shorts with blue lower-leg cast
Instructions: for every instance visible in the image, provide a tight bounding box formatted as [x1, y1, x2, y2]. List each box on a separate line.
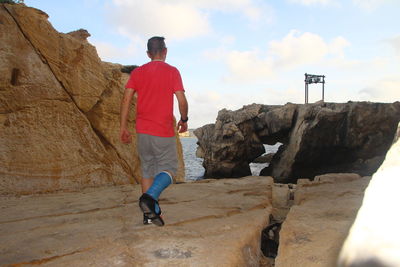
[120, 37, 188, 226]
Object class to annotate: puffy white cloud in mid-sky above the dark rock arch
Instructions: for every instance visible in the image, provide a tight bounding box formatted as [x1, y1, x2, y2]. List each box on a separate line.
[216, 30, 350, 82]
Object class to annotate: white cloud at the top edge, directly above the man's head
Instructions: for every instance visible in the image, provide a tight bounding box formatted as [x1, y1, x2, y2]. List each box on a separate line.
[110, 0, 273, 40]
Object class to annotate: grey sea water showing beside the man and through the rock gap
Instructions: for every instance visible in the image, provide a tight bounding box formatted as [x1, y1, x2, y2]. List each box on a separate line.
[180, 137, 281, 181]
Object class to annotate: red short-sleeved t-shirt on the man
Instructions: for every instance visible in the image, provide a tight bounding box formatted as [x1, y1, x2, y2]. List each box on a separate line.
[125, 61, 185, 137]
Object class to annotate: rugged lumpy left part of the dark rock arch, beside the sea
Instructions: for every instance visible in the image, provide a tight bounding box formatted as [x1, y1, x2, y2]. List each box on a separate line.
[194, 104, 280, 178]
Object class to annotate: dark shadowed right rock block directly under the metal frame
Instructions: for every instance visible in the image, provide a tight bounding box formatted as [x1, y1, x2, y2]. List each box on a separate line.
[263, 102, 400, 182]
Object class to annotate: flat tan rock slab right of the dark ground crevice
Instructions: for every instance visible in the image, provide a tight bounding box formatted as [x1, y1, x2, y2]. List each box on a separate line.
[275, 177, 369, 267]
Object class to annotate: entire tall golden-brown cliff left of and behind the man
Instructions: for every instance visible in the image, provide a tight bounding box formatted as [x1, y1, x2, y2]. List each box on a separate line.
[0, 4, 184, 194]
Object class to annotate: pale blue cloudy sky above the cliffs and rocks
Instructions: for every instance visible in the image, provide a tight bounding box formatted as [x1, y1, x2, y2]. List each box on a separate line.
[25, 0, 400, 128]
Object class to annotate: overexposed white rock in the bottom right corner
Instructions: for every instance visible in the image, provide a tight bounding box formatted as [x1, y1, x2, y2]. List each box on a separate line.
[339, 125, 400, 267]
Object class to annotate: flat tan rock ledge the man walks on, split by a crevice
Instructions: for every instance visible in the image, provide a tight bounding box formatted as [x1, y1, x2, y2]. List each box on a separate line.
[0, 174, 376, 267]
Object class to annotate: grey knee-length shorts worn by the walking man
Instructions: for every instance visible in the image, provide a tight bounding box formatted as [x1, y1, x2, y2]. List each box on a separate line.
[137, 134, 178, 178]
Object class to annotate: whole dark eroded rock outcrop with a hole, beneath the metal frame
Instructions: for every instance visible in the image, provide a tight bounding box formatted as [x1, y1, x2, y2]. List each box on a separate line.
[195, 102, 400, 182]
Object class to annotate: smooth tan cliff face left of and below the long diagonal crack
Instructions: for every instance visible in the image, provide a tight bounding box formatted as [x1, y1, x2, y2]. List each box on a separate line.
[0, 5, 130, 194]
